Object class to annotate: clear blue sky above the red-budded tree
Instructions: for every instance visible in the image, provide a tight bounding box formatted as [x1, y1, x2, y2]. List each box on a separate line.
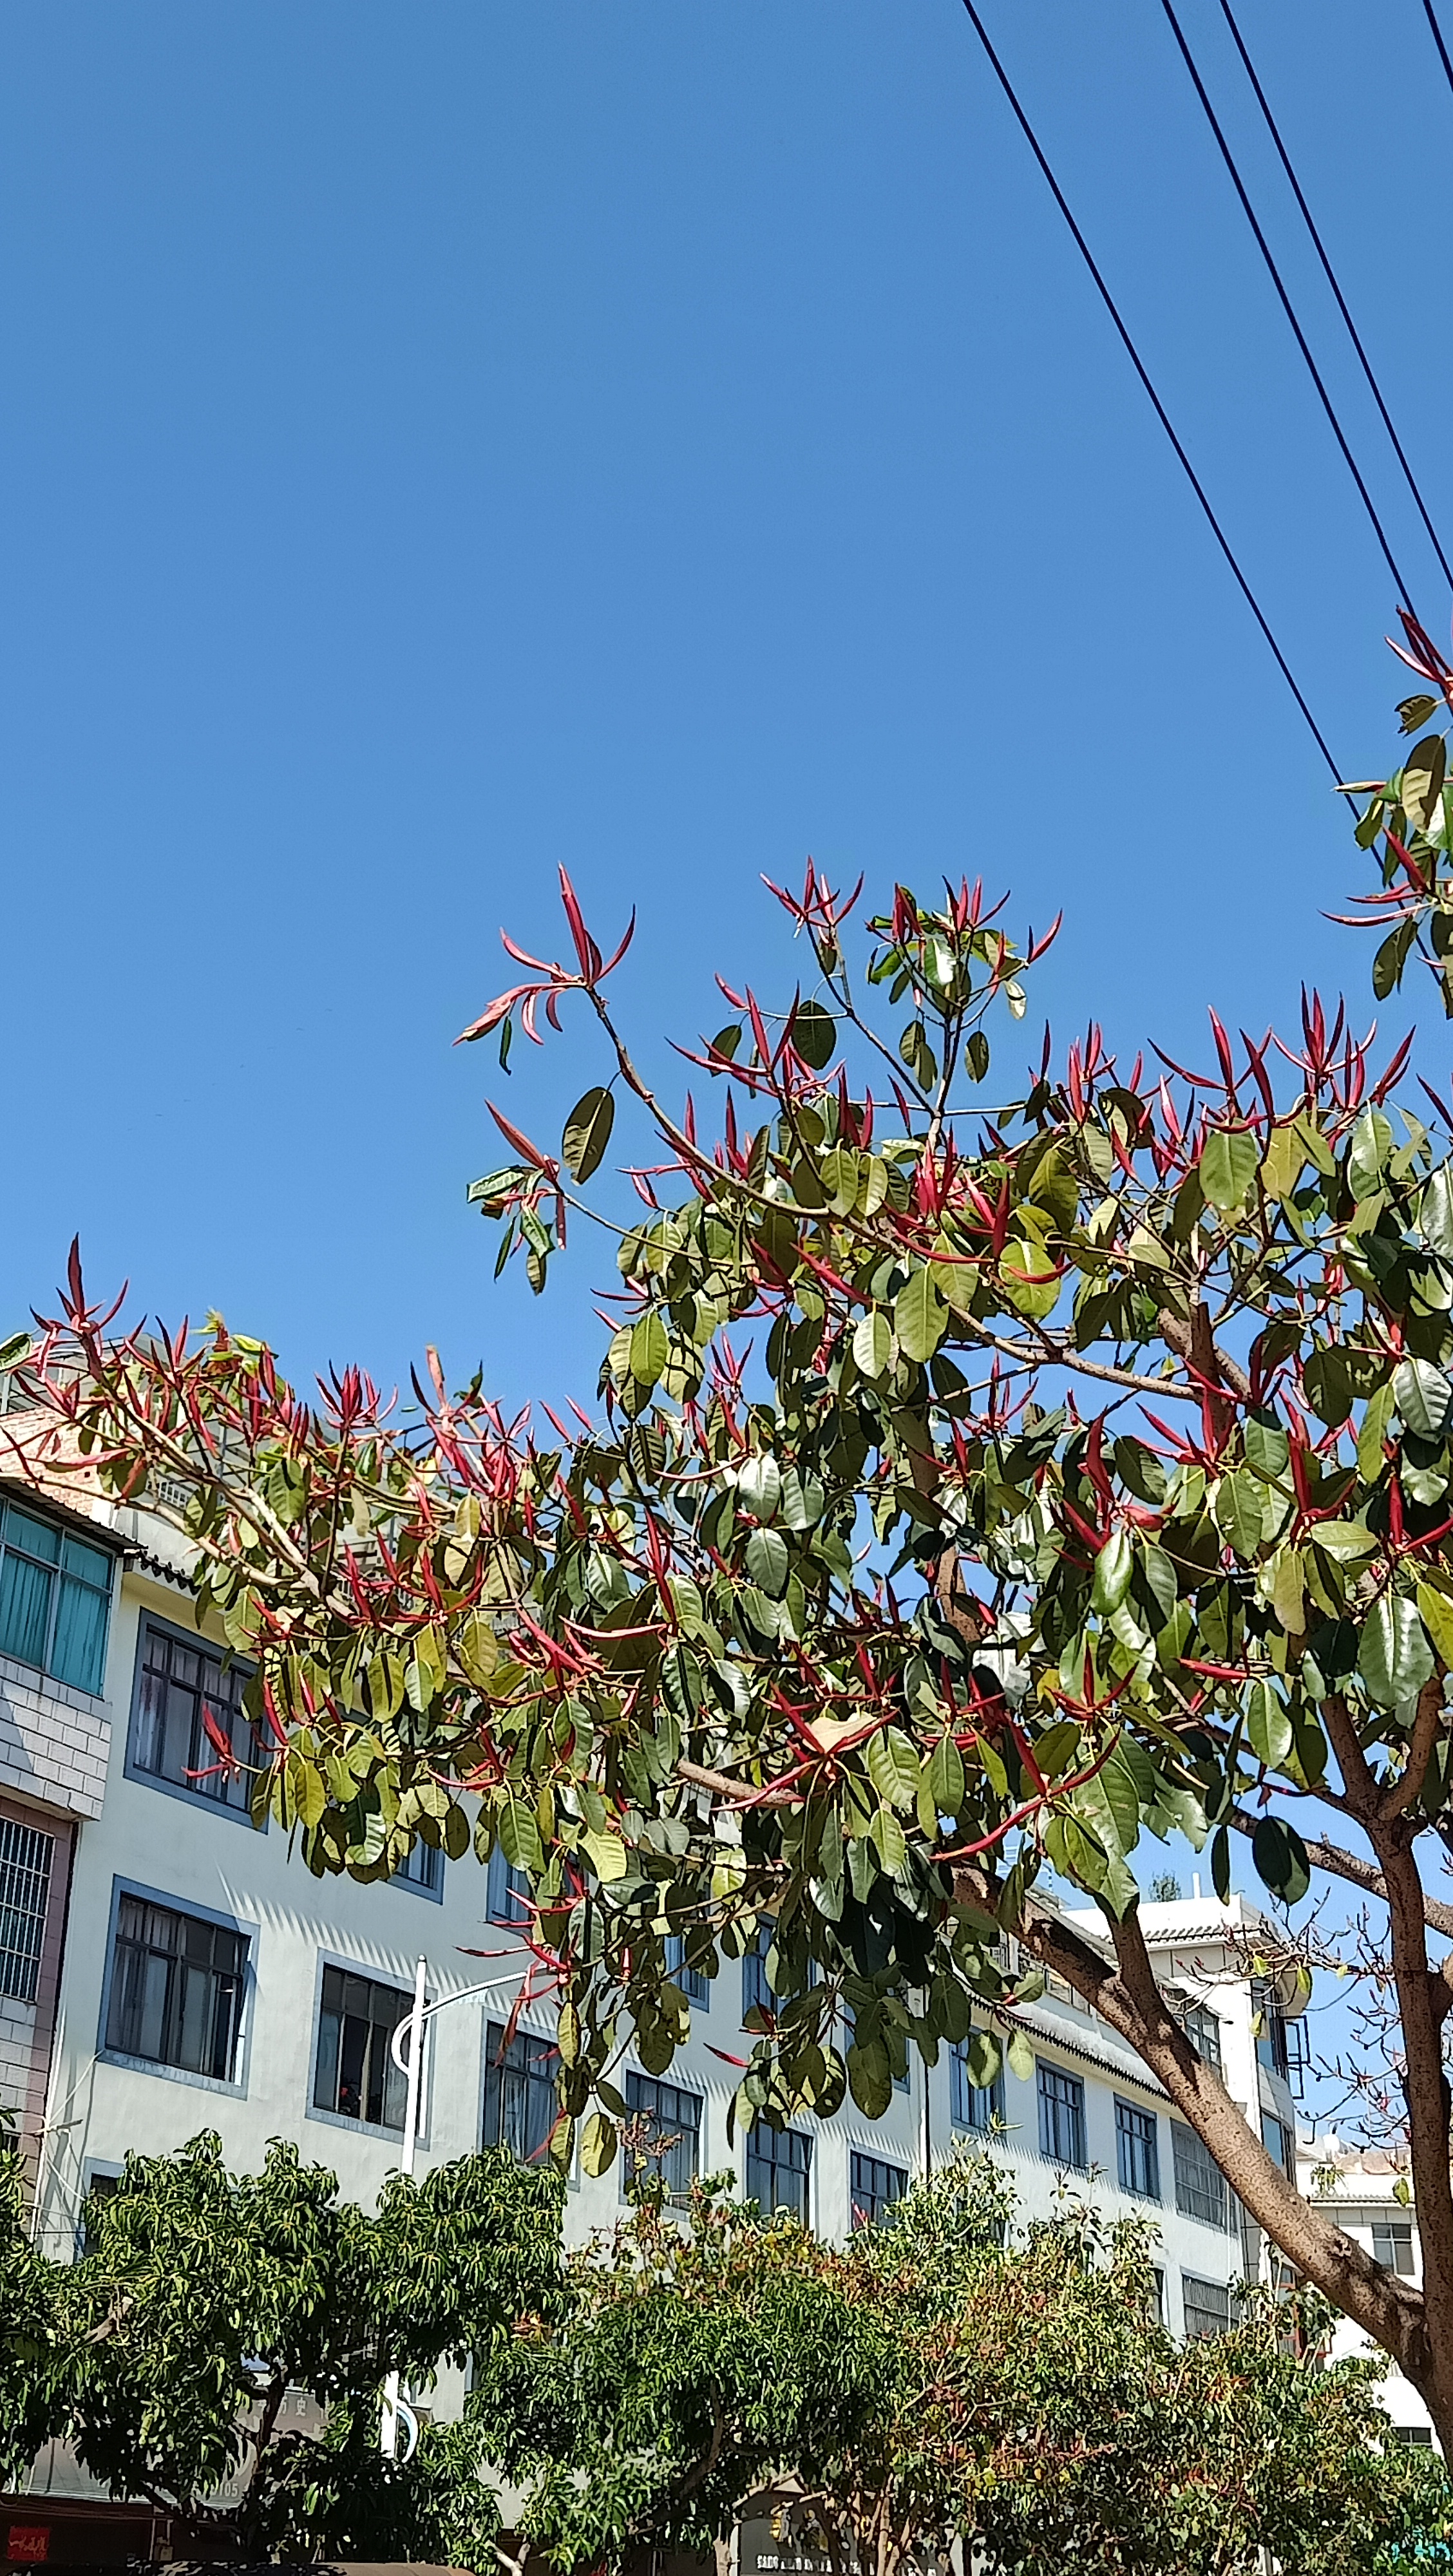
[0, 0, 1453, 1399]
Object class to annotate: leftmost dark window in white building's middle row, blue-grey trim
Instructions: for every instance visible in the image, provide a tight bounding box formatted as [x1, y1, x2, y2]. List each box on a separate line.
[106, 1896, 247, 2084]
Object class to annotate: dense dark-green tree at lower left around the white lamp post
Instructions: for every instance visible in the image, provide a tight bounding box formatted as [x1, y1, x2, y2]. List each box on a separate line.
[57, 2136, 562, 2563]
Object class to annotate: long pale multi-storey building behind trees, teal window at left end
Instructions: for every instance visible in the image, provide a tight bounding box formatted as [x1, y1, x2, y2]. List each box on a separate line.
[0, 1391, 1296, 2334]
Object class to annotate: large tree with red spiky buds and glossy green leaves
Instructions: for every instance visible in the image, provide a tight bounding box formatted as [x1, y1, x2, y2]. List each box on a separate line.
[23, 621, 1453, 2442]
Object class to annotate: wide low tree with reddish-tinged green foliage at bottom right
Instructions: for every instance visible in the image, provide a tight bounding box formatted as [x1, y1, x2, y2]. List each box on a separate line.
[471, 2156, 1448, 2576]
